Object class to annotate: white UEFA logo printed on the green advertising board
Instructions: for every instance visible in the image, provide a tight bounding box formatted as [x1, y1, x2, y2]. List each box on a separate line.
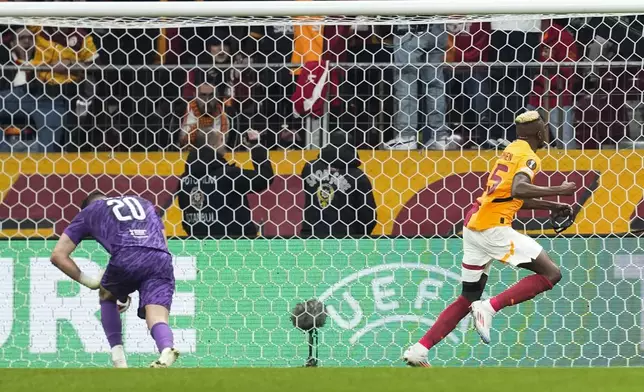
[318, 263, 469, 344]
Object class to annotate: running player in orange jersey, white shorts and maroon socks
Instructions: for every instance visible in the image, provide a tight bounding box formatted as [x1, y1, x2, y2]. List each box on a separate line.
[403, 111, 577, 366]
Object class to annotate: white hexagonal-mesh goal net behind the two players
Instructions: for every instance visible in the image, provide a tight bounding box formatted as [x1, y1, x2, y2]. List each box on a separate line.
[0, 0, 644, 367]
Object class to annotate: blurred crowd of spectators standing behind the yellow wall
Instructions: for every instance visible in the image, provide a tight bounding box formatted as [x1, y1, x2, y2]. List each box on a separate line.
[0, 1, 644, 152]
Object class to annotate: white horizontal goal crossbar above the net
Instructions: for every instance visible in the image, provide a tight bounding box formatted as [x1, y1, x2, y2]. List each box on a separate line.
[0, 0, 644, 18]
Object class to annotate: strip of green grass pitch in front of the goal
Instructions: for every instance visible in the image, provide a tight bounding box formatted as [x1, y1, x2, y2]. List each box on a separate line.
[0, 368, 644, 392]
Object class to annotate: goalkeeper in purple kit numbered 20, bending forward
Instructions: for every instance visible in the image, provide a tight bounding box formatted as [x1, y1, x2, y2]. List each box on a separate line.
[51, 193, 179, 368]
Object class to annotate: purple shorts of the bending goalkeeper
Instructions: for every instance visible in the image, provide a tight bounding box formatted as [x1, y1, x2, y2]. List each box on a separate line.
[101, 248, 174, 319]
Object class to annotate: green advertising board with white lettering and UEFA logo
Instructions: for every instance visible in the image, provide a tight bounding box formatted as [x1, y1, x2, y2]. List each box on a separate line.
[0, 238, 644, 367]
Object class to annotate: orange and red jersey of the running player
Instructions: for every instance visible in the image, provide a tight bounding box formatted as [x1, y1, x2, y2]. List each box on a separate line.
[465, 140, 541, 231]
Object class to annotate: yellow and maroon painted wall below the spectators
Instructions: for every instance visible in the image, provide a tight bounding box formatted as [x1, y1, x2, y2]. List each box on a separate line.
[0, 150, 644, 238]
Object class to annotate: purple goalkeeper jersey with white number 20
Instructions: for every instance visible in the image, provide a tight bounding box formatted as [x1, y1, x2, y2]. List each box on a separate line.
[65, 196, 169, 256]
